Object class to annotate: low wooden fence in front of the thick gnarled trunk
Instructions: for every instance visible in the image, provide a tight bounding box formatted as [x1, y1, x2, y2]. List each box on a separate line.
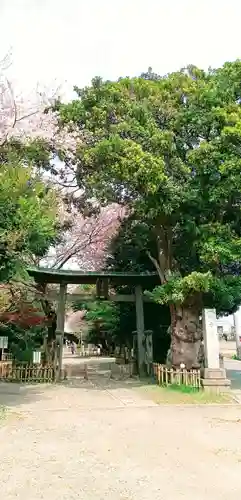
[153, 363, 201, 389]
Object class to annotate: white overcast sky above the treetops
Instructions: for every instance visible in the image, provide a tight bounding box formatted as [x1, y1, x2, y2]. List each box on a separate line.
[0, 0, 241, 98]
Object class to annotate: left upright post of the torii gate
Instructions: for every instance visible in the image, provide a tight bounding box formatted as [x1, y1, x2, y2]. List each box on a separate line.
[56, 283, 67, 379]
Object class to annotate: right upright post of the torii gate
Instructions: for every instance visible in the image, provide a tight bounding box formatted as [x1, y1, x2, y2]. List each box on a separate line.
[135, 285, 145, 375]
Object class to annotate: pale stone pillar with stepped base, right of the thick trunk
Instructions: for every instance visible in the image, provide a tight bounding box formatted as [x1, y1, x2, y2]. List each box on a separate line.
[202, 309, 230, 392]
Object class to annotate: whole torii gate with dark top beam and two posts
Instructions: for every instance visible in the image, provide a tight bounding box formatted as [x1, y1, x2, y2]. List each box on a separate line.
[28, 268, 159, 374]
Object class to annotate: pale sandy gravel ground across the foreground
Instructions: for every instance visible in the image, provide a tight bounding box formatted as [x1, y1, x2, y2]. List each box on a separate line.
[0, 377, 241, 500]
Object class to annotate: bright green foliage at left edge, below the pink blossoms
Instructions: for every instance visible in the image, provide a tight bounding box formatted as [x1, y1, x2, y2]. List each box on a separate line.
[0, 159, 57, 282]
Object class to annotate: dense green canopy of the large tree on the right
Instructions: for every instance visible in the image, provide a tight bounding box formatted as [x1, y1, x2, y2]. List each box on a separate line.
[58, 61, 241, 312]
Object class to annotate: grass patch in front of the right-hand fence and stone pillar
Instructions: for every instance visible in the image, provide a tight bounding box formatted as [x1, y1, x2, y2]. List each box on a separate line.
[139, 384, 235, 405]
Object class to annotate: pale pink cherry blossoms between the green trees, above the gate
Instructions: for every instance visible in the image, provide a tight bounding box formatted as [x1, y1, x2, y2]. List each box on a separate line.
[0, 53, 125, 270]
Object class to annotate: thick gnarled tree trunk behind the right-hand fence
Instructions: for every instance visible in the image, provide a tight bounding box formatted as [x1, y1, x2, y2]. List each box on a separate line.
[169, 301, 202, 369]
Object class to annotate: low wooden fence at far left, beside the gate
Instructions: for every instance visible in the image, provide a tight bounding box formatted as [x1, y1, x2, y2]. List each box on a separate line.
[0, 361, 56, 384]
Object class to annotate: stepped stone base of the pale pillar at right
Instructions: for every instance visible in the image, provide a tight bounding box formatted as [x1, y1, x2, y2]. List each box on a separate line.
[201, 368, 231, 392]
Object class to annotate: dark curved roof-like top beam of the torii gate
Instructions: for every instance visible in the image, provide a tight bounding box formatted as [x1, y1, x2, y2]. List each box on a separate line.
[28, 267, 160, 286]
